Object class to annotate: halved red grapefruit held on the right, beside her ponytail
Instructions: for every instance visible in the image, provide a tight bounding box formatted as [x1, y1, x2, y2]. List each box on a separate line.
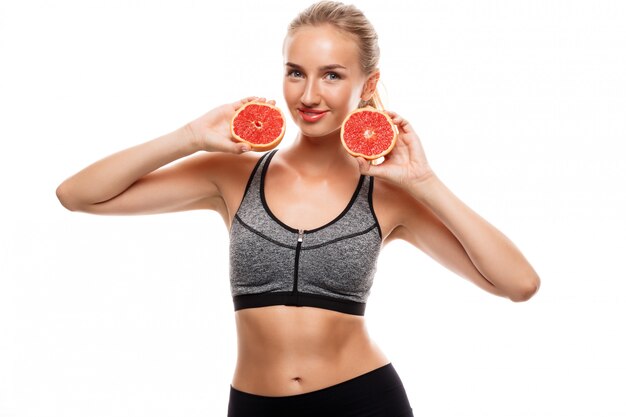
[341, 106, 398, 160]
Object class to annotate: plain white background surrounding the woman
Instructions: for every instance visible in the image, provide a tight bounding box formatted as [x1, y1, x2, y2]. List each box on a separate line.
[0, 0, 626, 417]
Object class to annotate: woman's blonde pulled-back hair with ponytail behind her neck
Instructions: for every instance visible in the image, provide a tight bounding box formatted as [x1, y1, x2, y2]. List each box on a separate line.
[285, 0, 383, 110]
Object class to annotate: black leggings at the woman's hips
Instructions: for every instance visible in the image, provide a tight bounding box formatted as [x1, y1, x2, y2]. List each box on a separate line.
[228, 363, 413, 417]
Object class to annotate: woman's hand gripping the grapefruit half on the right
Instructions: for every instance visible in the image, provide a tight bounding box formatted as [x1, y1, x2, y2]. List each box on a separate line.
[356, 110, 434, 188]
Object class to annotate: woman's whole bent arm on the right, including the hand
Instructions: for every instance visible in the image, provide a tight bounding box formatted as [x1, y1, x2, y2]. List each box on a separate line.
[357, 111, 540, 301]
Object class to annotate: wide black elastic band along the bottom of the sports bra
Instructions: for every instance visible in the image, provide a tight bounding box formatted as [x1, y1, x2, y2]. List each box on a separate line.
[233, 291, 366, 316]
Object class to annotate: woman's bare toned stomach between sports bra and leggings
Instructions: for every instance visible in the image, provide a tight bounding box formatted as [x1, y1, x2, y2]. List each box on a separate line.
[231, 305, 389, 397]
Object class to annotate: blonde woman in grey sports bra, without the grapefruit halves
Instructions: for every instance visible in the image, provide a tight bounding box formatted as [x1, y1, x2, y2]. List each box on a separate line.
[57, 1, 539, 417]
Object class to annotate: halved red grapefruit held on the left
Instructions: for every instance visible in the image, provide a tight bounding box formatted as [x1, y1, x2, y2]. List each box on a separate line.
[230, 101, 286, 151]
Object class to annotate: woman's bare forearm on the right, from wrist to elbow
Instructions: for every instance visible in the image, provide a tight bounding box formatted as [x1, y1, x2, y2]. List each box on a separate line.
[408, 174, 539, 301]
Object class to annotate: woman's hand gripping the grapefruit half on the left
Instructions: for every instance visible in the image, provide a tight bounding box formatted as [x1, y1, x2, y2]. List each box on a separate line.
[185, 96, 276, 153]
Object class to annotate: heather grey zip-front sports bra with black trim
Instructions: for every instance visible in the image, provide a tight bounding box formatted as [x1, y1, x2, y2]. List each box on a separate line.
[229, 149, 382, 316]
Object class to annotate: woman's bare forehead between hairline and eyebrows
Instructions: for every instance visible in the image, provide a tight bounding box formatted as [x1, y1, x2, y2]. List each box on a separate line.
[283, 25, 358, 69]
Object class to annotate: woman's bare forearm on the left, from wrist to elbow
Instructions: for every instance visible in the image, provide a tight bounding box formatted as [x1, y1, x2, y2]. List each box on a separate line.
[56, 126, 199, 208]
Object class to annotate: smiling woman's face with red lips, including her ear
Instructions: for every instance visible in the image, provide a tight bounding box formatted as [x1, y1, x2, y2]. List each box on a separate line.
[283, 25, 377, 137]
